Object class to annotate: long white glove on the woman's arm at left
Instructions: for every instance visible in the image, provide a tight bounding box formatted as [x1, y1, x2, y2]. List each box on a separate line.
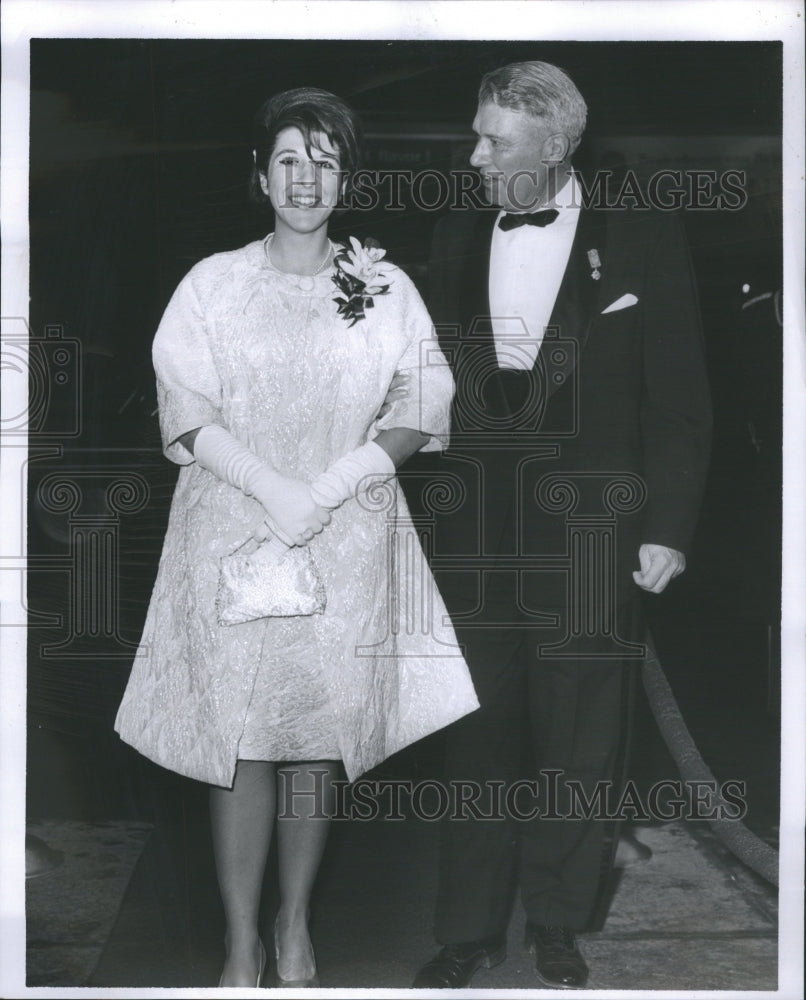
[193, 424, 330, 545]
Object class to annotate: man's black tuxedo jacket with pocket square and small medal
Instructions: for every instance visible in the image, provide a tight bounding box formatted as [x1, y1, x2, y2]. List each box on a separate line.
[410, 201, 711, 605]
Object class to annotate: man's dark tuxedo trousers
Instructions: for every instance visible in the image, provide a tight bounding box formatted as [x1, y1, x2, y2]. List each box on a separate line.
[435, 587, 641, 944]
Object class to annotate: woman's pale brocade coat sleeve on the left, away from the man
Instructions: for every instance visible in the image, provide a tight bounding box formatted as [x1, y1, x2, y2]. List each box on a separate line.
[152, 265, 224, 465]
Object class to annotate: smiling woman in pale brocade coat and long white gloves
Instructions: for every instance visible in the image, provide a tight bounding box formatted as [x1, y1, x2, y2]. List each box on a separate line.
[116, 89, 478, 986]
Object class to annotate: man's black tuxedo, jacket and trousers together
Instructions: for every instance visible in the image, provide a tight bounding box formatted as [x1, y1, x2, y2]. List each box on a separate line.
[410, 197, 711, 943]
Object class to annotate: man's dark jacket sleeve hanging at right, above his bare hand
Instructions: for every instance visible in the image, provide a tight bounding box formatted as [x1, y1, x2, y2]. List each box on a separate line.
[641, 216, 712, 552]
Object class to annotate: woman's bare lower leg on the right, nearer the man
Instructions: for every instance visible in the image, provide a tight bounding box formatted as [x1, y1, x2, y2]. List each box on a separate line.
[275, 761, 340, 981]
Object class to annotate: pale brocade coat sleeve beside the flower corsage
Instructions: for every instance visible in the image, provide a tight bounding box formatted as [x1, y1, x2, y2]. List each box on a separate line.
[370, 271, 454, 451]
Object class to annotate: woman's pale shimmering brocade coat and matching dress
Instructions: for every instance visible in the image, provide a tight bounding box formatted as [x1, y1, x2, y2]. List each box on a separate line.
[115, 242, 478, 786]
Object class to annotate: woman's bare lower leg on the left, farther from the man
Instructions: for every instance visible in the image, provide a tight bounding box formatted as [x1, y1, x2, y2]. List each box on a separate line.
[210, 760, 277, 987]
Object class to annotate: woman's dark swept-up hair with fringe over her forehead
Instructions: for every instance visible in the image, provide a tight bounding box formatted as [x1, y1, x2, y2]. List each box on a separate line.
[249, 87, 363, 207]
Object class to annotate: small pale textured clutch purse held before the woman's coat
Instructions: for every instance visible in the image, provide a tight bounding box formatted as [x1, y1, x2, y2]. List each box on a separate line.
[216, 537, 327, 625]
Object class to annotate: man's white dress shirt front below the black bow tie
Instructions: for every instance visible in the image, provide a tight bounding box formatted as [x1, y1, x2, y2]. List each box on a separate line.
[490, 174, 580, 370]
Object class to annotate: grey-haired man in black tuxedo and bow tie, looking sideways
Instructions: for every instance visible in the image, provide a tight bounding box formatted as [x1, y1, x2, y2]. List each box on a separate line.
[414, 62, 711, 988]
